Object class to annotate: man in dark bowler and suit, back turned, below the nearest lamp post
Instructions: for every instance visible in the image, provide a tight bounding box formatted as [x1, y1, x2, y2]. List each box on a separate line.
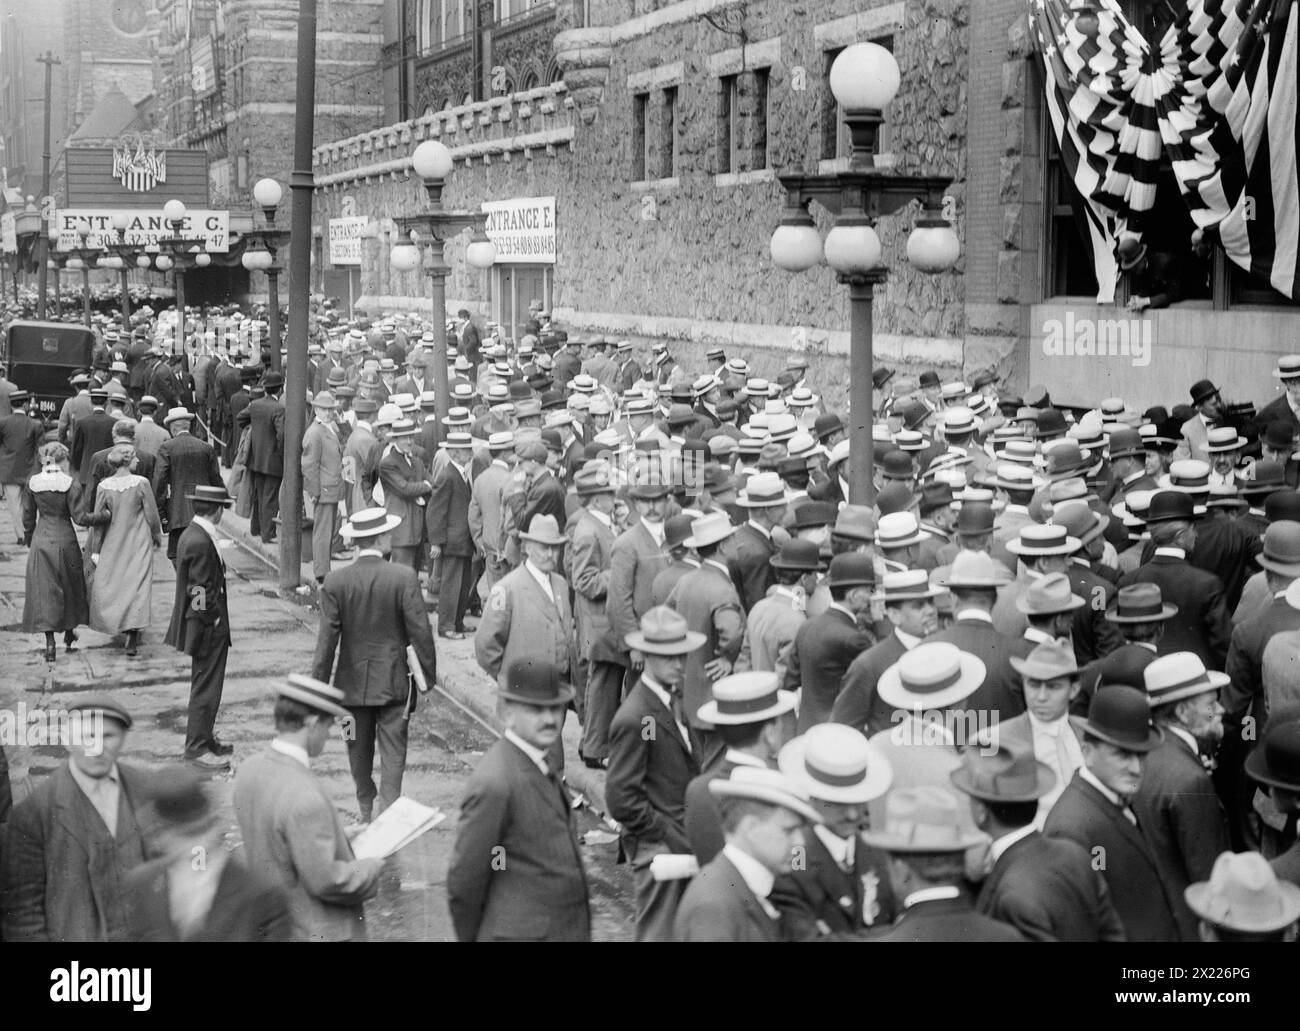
[784, 553, 876, 733]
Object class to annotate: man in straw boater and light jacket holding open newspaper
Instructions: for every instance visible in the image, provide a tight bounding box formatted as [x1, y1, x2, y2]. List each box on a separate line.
[234, 673, 384, 941]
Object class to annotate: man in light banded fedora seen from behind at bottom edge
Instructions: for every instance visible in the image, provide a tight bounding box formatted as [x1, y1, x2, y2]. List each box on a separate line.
[862, 784, 1024, 943]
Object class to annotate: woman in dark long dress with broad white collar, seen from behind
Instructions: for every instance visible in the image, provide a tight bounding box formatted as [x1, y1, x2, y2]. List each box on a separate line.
[22, 442, 88, 662]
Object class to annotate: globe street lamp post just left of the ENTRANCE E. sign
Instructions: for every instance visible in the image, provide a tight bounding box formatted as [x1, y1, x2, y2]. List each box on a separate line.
[389, 139, 497, 419]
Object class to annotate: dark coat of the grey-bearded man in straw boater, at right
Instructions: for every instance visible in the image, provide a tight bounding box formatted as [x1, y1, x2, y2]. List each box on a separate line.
[1134, 727, 1229, 941]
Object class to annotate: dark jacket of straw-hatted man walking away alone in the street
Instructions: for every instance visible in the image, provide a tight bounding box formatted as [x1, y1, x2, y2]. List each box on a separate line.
[312, 553, 438, 706]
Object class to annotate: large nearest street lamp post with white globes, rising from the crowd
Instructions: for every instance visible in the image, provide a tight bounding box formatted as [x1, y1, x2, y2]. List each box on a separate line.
[771, 43, 959, 504]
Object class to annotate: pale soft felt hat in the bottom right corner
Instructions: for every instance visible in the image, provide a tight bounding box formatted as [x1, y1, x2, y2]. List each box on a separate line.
[1183, 852, 1300, 933]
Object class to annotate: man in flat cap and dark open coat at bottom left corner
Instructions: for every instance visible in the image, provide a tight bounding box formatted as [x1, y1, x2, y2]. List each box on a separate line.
[3, 694, 148, 943]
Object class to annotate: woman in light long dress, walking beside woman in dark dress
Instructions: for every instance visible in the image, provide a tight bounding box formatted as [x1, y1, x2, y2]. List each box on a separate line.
[87, 443, 163, 655]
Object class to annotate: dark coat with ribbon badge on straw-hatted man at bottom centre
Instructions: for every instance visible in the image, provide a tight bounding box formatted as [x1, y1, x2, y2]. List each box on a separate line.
[771, 829, 898, 941]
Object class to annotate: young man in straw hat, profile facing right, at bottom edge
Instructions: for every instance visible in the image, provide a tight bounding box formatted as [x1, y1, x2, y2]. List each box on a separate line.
[673, 766, 822, 941]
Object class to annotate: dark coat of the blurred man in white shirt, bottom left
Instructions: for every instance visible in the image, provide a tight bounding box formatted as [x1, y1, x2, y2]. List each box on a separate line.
[126, 858, 293, 943]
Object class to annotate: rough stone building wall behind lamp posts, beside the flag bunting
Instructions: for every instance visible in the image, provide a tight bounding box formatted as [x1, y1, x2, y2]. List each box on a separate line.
[315, 0, 1294, 406]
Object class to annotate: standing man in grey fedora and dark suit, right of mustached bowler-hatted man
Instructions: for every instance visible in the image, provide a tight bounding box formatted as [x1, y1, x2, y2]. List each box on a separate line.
[605, 606, 705, 941]
